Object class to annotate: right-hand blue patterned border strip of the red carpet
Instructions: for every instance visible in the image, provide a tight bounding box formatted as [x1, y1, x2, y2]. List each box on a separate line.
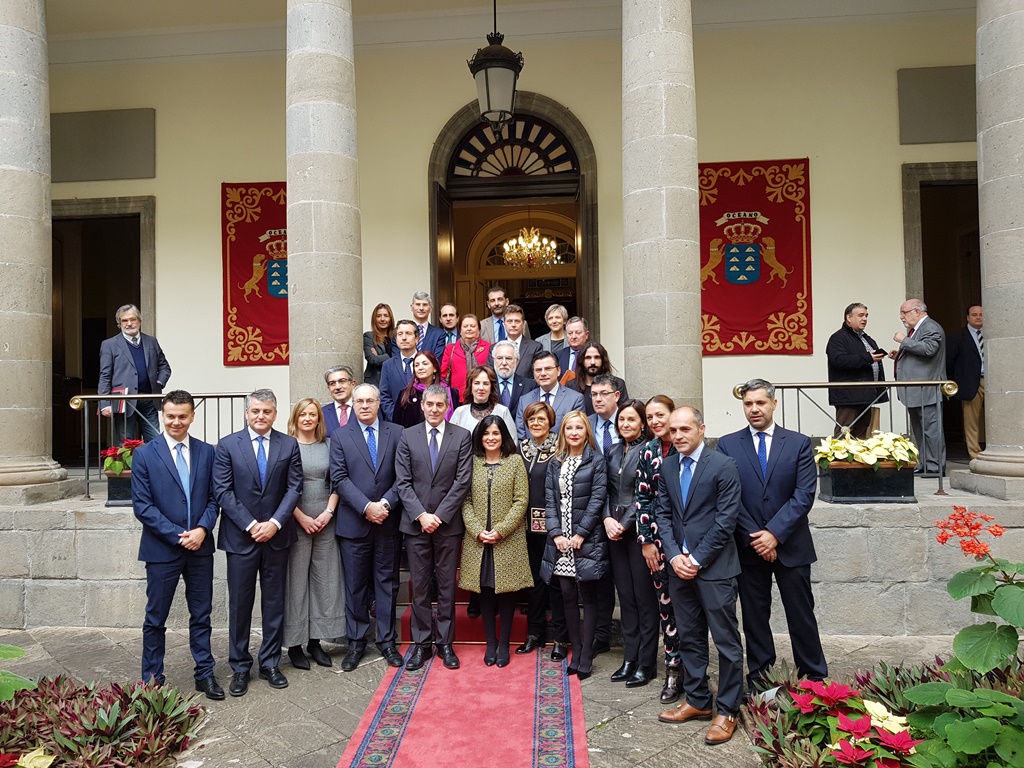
[534, 651, 575, 768]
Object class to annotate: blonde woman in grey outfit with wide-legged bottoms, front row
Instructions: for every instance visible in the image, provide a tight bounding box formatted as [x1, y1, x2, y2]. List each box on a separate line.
[285, 397, 345, 670]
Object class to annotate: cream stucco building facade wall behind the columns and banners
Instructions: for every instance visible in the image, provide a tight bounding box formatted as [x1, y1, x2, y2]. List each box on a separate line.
[50, 14, 976, 434]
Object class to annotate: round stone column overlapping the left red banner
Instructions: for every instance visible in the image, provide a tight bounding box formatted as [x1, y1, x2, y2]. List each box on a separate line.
[288, 0, 365, 410]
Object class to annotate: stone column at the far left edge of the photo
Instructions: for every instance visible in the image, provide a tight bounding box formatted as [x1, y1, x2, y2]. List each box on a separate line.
[0, 0, 67, 487]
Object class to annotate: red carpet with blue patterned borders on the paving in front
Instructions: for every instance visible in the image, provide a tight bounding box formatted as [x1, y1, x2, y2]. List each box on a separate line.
[338, 645, 590, 768]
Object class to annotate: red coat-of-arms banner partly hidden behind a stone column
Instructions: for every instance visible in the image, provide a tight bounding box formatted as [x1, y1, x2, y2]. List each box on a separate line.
[220, 181, 288, 366]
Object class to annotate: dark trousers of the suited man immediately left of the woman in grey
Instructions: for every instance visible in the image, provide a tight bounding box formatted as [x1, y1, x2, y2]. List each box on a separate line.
[227, 543, 288, 672]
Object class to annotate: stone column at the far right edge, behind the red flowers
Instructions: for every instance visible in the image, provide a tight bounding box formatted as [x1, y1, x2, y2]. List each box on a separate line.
[971, 0, 1024, 499]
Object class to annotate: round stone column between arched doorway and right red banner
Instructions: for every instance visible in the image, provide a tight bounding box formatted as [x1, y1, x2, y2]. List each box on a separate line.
[623, 0, 703, 410]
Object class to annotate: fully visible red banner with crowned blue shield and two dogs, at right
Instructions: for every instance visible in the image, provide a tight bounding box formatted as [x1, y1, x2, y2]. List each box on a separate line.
[699, 158, 813, 355]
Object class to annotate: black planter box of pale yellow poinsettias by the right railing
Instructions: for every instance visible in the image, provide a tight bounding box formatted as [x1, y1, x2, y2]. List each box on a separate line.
[814, 431, 918, 504]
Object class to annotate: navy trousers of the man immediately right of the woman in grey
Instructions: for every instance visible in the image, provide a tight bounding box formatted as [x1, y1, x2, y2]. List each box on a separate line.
[338, 524, 401, 649]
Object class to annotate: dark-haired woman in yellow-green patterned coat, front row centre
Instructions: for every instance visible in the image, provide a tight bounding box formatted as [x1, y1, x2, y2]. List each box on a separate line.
[459, 414, 534, 667]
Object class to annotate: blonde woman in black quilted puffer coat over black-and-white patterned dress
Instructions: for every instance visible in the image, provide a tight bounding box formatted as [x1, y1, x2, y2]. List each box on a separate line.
[541, 411, 608, 680]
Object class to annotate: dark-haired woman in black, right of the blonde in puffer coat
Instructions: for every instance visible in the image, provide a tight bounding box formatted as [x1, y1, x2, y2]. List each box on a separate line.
[604, 400, 659, 688]
